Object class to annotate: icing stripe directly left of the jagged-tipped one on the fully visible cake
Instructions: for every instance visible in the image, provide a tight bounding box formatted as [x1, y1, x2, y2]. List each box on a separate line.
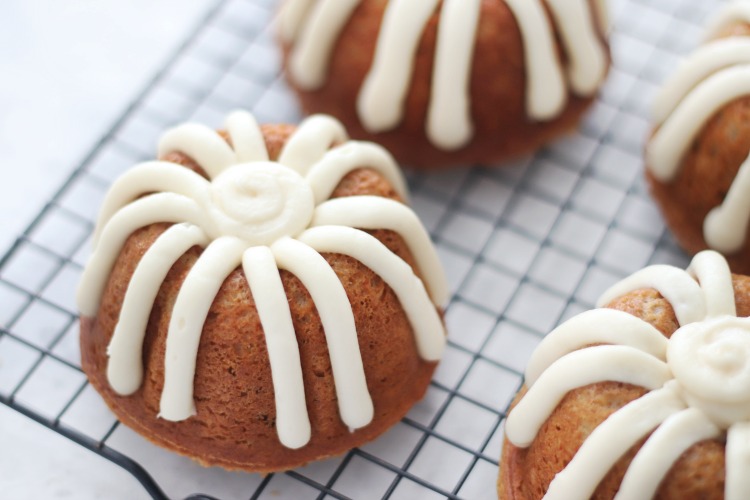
[107, 224, 209, 396]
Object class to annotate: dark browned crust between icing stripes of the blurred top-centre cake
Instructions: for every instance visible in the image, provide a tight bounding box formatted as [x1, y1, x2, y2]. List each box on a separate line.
[283, 0, 612, 170]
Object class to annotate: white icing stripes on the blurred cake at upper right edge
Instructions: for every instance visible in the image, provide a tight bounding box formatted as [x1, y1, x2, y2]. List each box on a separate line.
[646, 2, 750, 254]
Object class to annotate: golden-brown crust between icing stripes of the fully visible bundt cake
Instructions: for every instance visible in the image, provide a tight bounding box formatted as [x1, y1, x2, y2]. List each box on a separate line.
[81, 126, 435, 472]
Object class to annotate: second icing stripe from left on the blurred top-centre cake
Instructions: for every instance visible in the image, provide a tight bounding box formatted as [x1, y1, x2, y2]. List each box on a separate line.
[289, 0, 361, 90]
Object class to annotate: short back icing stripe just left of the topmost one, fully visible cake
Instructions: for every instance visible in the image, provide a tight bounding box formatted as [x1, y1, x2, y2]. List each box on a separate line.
[159, 123, 237, 179]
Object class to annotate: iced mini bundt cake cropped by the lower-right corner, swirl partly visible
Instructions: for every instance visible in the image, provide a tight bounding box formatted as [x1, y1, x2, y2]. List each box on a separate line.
[498, 250, 750, 500]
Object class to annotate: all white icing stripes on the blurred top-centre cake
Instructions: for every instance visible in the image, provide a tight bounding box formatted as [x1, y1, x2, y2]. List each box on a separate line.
[281, 0, 608, 150]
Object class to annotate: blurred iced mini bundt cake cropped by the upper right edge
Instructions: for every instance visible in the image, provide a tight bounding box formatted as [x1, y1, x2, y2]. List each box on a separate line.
[646, 2, 750, 274]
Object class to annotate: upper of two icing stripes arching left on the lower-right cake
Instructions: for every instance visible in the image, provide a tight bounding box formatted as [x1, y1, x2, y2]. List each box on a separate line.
[526, 309, 667, 386]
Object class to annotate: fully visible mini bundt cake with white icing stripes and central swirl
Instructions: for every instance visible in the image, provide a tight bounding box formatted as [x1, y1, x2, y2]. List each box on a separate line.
[78, 111, 447, 472]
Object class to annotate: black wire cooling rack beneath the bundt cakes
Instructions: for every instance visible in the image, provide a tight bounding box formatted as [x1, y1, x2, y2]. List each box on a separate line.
[0, 0, 720, 499]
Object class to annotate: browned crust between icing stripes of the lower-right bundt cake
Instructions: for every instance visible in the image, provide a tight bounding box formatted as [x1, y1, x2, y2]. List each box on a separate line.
[497, 274, 750, 500]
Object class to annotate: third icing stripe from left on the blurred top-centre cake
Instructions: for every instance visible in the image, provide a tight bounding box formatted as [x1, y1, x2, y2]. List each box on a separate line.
[357, 0, 439, 133]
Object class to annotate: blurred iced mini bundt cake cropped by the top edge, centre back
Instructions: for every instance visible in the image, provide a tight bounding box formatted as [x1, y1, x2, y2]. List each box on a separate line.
[280, 0, 609, 169]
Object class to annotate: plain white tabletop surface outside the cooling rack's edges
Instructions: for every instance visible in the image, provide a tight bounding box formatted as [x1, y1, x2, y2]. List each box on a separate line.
[0, 0, 217, 499]
